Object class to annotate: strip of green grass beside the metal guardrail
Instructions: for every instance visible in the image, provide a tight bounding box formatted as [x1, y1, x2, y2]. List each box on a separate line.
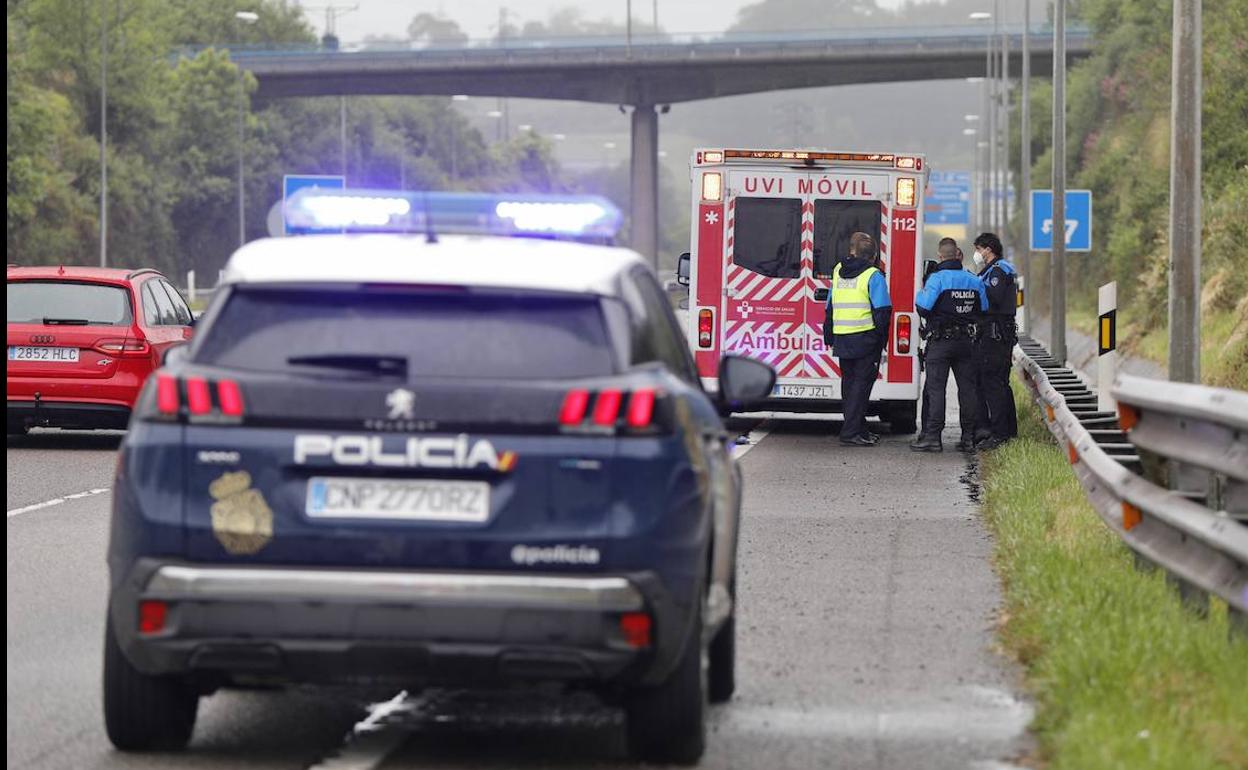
[981, 381, 1248, 770]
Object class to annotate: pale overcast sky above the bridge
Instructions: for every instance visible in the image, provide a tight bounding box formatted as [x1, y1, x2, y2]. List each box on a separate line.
[300, 0, 918, 42]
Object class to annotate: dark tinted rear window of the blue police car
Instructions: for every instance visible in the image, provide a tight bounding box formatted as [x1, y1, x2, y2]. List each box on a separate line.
[193, 286, 615, 379]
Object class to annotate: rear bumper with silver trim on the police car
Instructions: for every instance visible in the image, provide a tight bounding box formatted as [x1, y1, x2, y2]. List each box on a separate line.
[110, 559, 690, 685]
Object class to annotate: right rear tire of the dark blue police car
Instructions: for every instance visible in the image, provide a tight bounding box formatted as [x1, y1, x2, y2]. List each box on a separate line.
[624, 589, 706, 765]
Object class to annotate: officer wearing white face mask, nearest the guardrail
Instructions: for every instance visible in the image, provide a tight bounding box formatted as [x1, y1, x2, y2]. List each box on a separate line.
[973, 232, 1018, 449]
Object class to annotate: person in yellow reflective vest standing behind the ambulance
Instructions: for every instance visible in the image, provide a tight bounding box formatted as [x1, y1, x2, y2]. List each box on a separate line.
[824, 232, 892, 447]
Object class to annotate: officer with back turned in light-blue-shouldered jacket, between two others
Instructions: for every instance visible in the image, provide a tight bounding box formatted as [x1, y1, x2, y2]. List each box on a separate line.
[910, 238, 988, 452]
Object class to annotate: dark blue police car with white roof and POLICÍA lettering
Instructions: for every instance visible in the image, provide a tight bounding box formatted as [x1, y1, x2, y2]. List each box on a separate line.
[104, 187, 775, 763]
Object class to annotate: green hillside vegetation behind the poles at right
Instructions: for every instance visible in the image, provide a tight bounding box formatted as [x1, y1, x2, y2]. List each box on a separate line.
[1011, 0, 1248, 389]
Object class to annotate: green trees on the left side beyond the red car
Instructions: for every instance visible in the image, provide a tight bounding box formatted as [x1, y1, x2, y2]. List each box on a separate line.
[7, 0, 562, 276]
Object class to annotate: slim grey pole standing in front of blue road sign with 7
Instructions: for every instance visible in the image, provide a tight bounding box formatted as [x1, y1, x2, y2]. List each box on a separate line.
[1048, 0, 1066, 364]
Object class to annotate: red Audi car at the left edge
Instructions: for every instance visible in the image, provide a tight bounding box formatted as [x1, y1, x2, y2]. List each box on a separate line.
[5, 266, 195, 436]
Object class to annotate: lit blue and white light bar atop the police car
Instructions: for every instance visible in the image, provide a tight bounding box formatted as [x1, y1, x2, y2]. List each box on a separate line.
[285, 187, 623, 238]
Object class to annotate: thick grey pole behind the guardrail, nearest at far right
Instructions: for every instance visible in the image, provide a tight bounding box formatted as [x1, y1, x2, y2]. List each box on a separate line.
[1168, 0, 1201, 382]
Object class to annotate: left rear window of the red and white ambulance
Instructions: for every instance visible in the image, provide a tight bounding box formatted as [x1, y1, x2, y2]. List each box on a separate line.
[733, 197, 801, 278]
